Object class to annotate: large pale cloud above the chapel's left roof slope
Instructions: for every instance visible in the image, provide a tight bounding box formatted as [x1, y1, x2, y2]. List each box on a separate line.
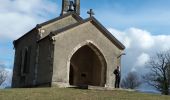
[0, 0, 58, 41]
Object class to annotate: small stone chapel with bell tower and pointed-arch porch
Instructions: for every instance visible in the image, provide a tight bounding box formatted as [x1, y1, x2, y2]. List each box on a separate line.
[12, 0, 125, 88]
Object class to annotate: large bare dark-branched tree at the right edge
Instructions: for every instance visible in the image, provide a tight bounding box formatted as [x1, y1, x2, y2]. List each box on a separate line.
[143, 51, 170, 95]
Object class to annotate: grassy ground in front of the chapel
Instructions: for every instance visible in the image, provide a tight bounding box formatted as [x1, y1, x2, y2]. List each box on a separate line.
[0, 88, 170, 100]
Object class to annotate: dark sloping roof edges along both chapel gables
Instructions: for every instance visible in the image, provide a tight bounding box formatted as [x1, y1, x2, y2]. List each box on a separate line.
[14, 12, 125, 50]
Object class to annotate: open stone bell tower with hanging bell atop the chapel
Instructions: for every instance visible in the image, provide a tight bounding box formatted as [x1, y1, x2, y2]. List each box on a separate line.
[60, 0, 80, 16]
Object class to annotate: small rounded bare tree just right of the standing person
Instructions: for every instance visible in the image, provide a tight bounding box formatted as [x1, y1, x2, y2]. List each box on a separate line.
[121, 72, 142, 89]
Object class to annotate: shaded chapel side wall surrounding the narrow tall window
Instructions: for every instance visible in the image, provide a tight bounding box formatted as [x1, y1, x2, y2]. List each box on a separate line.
[12, 29, 38, 87]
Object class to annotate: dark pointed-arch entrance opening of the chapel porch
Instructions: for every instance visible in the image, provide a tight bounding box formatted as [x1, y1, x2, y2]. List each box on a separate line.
[69, 43, 107, 86]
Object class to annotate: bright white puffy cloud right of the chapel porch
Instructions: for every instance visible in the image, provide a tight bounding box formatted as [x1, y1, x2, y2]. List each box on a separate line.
[108, 28, 170, 76]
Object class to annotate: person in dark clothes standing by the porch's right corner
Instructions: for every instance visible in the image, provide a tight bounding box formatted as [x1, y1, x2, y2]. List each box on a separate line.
[113, 66, 120, 88]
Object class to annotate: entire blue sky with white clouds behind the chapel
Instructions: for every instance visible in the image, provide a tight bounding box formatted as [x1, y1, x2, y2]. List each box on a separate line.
[0, 0, 170, 89]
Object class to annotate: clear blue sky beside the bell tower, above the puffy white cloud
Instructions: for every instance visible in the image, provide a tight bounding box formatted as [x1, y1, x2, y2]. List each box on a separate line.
[40, 0, 170, 34]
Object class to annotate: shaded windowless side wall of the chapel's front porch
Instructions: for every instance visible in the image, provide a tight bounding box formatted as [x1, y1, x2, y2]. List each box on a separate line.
[36, 38, 54, 85]
